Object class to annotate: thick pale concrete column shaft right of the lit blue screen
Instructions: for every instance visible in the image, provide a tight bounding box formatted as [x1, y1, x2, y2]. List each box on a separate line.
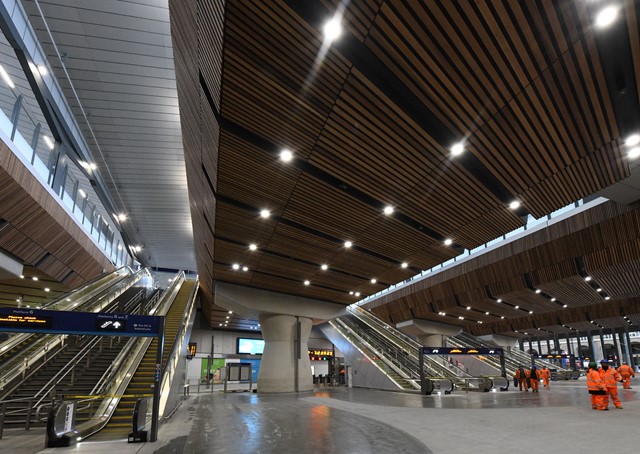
[258, 314, 313, 393]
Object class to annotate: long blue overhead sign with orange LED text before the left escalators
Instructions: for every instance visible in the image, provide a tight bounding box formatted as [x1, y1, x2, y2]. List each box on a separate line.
[0, 308, 162, 337]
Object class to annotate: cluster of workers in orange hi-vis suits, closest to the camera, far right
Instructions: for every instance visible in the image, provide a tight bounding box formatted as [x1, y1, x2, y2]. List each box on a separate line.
[587, 359, 636, 411]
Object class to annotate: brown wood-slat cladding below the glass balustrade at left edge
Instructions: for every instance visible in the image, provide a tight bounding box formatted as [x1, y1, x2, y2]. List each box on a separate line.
[0, 143, 114, 294]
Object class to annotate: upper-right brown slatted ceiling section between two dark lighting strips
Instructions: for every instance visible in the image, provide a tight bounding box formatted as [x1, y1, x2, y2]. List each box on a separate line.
[367, 2, 619, 216]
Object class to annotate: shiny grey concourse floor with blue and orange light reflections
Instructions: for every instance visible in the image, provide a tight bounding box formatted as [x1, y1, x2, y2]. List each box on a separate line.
[0, 377, 640, 454]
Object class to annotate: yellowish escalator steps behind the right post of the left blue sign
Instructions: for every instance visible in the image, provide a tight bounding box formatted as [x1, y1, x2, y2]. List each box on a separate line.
[88, 280, 197, 442]
